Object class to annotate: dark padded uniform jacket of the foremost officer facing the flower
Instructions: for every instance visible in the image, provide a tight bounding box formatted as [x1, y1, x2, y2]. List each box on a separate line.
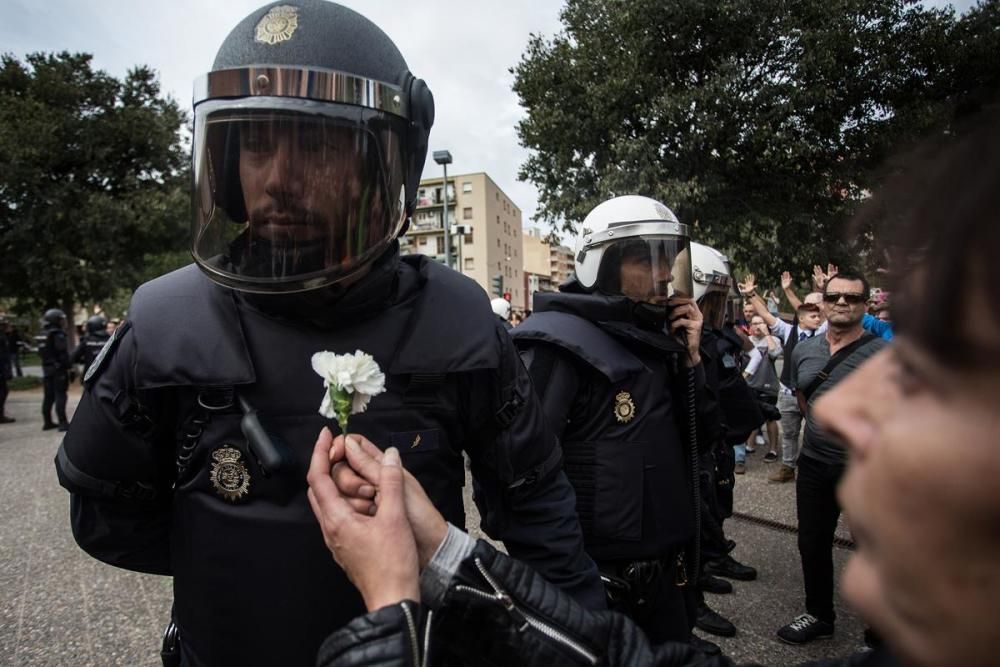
[56, 253, 603, 665]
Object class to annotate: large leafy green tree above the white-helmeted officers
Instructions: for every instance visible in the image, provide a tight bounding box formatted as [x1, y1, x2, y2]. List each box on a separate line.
[512, 0, 998, 283]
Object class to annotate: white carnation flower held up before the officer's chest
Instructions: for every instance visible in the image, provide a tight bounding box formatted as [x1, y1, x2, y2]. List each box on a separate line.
[312, 350, 385, 433]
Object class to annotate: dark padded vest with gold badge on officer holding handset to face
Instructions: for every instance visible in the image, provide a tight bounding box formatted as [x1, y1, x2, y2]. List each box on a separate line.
[512, 302, 695, 561]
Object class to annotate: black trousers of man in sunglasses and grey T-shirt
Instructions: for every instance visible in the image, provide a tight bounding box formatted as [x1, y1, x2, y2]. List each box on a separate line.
[795, 455, 844, 623]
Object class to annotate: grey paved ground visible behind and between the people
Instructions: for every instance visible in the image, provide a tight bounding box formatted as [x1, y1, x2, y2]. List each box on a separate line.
[0, 392, 862, 667]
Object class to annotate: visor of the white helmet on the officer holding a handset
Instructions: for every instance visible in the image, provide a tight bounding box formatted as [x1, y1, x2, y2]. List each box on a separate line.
[597, 236, 693, 305]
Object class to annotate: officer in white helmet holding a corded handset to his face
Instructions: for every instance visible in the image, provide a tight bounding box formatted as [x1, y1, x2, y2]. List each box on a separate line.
[512, 196, 719, 651]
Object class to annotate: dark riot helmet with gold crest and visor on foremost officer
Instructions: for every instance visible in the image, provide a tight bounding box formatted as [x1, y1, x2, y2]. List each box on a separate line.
[191, 0, 434, 293]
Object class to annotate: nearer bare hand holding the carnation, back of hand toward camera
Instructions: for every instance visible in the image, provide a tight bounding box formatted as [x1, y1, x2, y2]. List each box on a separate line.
[306, 428, 420, 611]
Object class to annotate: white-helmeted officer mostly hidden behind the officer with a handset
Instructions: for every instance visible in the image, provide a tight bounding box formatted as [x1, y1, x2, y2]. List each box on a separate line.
[691, 242, 764, 637]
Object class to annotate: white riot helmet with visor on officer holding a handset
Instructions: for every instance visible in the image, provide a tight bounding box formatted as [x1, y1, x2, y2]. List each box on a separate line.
[575, 195, 692, 305]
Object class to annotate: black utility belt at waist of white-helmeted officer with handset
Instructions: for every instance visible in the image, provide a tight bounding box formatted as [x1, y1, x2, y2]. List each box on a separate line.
[597, 549, 688, 614]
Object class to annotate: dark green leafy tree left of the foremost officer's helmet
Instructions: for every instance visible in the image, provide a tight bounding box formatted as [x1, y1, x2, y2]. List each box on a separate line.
[0, 53, 189, 330]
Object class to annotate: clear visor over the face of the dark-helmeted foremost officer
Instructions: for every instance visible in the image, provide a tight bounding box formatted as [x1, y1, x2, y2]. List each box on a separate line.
[192, 99, 405, 292]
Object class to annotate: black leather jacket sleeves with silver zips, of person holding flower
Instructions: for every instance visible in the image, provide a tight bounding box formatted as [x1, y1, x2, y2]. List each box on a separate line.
[317, 541, 732, 667]
